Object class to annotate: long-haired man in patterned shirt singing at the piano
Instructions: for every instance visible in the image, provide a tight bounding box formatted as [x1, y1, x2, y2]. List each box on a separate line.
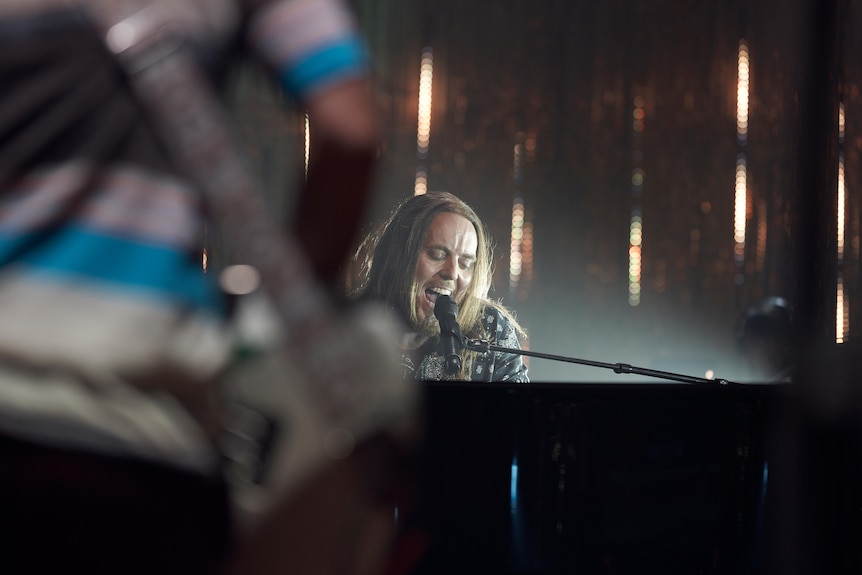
[349, 192, 529, 383]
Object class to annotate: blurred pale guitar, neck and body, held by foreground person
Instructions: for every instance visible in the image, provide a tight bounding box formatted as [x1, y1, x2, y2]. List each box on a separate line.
[81, 0, 418, 529]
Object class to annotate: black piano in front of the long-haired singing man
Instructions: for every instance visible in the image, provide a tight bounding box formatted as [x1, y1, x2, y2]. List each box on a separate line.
[405, 382, 860, 575]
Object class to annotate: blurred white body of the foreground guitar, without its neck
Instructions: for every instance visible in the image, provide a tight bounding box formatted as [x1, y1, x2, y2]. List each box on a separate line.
[221, 296, 418, 529]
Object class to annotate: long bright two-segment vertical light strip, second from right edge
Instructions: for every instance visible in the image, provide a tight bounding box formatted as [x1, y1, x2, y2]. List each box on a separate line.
[733, 38, 751, 285]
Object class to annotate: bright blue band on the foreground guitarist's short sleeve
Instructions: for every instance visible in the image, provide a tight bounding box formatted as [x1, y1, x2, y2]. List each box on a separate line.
[280, 38, 368, 98]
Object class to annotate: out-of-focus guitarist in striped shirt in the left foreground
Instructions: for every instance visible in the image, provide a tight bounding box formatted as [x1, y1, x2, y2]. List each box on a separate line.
[0, 0, 412, 574]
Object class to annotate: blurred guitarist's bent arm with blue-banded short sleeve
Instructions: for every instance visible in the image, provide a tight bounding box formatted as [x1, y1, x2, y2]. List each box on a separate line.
[249, 0, 380, 286]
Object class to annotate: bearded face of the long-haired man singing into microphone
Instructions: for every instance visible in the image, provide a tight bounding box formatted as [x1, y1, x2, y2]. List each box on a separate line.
[413, 212, 479, 324]
